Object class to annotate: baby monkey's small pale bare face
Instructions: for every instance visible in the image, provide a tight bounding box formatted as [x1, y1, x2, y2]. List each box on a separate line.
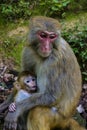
[24, 75, 37, 92]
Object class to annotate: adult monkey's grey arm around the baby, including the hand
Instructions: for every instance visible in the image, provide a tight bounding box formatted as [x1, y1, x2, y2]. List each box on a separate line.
[4, 93, 55, 130]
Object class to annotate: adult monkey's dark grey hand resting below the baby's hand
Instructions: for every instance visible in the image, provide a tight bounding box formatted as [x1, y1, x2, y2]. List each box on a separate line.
[3, 112, 18, 130]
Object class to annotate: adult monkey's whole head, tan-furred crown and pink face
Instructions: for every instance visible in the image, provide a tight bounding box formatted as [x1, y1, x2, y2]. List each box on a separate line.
[28, 16, 61, 57]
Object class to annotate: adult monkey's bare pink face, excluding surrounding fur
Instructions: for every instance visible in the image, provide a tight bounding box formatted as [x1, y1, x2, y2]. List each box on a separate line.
[37, 31, 58, 56]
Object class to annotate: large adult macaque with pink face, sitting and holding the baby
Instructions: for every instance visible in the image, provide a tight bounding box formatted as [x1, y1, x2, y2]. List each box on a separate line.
[0, 16, 85, 130]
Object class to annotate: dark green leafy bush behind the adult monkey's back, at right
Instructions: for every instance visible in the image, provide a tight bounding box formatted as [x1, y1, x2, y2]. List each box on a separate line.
[62, 25, 87, 82]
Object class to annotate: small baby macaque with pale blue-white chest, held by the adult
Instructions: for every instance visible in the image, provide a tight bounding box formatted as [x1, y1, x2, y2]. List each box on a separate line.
[9, 72, 37, 112]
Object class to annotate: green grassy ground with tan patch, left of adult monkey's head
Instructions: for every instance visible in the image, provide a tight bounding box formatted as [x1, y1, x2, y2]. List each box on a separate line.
[0, 18, 28, 67]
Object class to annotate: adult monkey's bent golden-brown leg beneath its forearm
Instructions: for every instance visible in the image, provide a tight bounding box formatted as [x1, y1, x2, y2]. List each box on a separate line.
[27, 107, 69, 130]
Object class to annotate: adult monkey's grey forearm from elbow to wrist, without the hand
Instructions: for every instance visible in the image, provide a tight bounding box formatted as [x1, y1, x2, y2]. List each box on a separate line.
[16, 93, 56, 116]
